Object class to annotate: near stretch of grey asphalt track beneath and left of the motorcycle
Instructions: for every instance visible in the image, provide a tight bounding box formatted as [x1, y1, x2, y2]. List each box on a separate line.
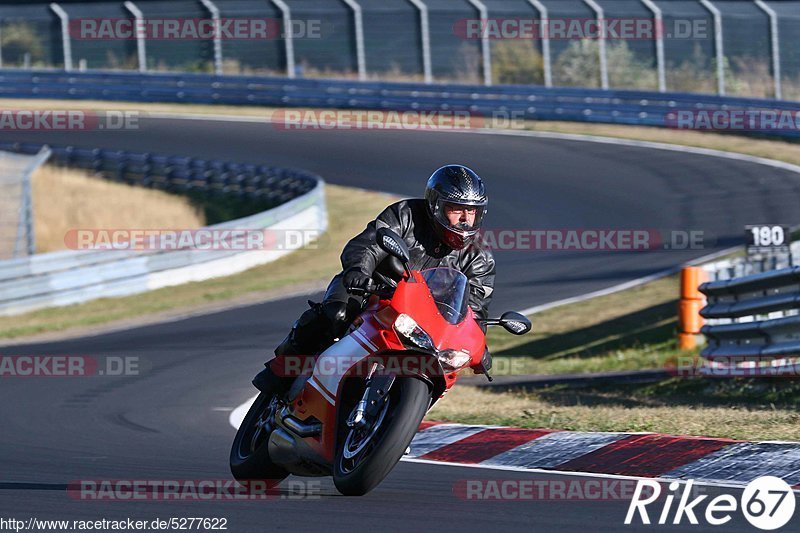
[0, 306, 768, 532]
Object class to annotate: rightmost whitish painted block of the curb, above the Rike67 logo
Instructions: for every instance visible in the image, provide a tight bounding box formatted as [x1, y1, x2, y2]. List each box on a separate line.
[663, 442, 800, 485]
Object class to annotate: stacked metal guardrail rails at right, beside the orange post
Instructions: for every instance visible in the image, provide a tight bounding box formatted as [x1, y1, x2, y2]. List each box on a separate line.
[700, 267, 800, 361]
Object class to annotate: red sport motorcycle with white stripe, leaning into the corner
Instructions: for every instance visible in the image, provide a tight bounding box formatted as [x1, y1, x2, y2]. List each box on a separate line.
[230, 228, 531, 495]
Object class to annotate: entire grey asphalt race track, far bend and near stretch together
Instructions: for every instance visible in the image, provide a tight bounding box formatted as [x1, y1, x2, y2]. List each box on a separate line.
[0, 119, 800, 531]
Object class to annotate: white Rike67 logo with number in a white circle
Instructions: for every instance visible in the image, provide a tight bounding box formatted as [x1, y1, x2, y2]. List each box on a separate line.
[625, 476, 795, 531]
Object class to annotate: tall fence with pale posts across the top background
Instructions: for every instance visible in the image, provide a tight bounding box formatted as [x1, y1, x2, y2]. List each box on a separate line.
[0, 0, 800, 99]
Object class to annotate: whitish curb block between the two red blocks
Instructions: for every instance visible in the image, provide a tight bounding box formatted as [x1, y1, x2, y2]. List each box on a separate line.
[480, 431, 628, 468]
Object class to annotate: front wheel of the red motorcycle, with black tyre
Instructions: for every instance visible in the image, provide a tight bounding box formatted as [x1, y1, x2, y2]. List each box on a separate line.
[333, 377, 430, 496]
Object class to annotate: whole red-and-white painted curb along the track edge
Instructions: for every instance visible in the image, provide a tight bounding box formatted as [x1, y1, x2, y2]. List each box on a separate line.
[406, 422, 800, 490]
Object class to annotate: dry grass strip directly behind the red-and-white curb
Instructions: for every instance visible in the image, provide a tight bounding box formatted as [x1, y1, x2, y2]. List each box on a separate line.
[428, 379, 800, 441]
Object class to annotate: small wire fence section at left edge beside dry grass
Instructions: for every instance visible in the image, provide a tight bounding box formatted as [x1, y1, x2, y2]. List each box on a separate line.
[0, 147, 50, 259]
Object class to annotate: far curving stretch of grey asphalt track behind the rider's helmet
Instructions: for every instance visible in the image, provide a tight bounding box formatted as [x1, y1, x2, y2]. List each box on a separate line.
[0, 118, 800, 311]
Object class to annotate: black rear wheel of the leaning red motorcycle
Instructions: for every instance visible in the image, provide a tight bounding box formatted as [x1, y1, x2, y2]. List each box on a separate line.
[230, 391, 289, 486]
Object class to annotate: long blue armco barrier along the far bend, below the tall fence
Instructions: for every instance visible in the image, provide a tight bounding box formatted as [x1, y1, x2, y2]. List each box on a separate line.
[0, 69, 800, 138]
